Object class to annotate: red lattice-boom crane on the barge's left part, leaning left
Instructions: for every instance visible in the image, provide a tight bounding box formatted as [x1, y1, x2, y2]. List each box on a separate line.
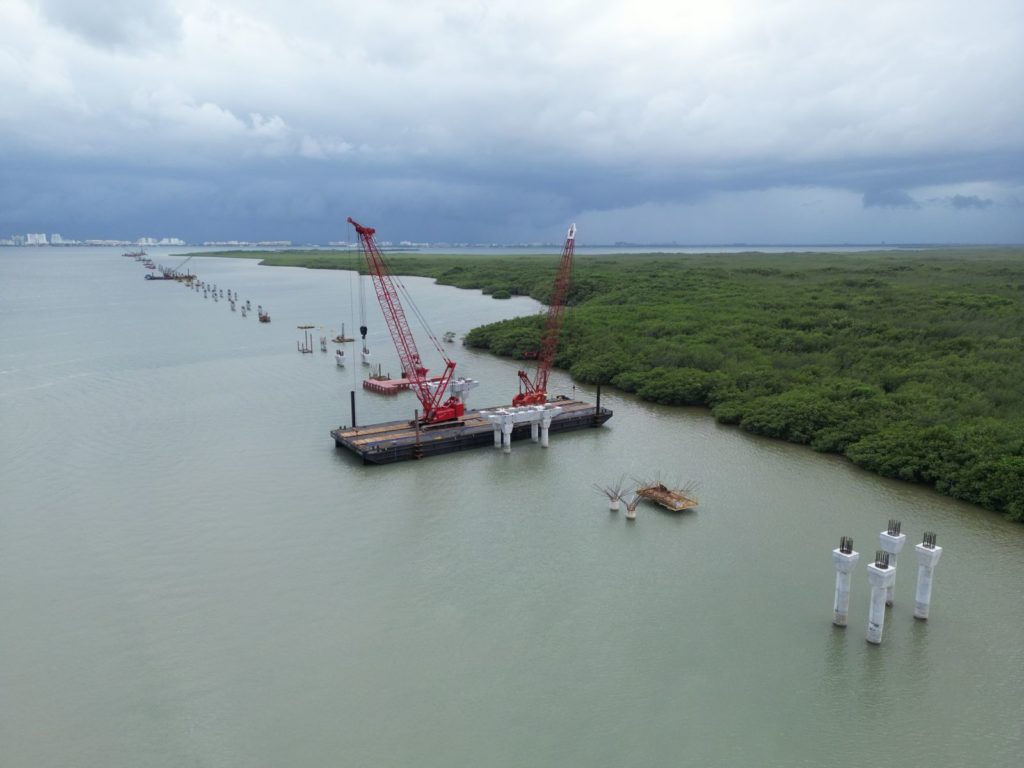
[348, 216, 466, 424]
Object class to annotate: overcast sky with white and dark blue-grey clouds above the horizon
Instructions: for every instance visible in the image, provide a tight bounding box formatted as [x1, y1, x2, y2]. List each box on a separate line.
[0, 0, 1024, 244]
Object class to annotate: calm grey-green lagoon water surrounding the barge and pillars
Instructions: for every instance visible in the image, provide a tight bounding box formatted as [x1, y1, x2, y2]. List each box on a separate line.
[0, 249, 1024, 768]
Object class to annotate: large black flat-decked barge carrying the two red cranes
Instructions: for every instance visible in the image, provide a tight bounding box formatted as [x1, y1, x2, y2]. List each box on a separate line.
[331, 399, 612, 464]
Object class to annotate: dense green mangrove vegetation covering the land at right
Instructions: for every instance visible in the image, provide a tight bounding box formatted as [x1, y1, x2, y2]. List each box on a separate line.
[197, 249, 1024, 520]
